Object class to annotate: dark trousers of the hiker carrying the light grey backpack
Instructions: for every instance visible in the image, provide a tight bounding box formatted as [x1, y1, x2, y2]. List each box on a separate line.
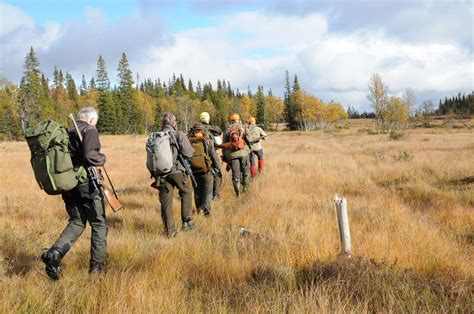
[159, 172, 193, 234]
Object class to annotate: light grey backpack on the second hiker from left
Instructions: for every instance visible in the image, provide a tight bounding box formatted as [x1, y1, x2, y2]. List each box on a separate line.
[145, 131, 173, 177]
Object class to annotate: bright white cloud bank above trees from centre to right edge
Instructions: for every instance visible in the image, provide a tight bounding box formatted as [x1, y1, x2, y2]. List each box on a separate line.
[138, 12, 474, 108]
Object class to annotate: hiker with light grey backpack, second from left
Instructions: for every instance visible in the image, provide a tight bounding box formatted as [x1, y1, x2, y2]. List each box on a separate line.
[147, 113, 195, 238]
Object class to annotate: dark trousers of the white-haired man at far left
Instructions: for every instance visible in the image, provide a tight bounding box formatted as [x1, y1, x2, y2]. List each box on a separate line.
[52, 191, 107, 263]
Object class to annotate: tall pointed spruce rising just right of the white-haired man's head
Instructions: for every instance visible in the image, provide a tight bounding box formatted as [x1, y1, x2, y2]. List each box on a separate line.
[95, 55, 119, 133]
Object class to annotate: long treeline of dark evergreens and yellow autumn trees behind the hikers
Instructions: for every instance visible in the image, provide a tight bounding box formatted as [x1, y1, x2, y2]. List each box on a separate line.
[0, 47, 347, 139]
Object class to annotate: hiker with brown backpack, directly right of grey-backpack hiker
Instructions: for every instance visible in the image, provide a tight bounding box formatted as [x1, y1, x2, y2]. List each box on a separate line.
[188, 122, 219, 216]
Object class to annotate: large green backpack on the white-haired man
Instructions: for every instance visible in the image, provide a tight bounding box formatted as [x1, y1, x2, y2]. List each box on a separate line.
[25, 120, 87, 195]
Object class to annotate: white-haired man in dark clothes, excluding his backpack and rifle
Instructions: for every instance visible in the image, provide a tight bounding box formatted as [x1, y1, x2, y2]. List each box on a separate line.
[41, 107, 107, 280]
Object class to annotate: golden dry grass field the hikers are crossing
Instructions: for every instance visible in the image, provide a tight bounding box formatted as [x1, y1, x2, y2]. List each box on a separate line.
[0, 124, 474, 313]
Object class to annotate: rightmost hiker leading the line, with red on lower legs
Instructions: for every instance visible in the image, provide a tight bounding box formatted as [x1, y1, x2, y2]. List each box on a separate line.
[245, 117, 267, 177]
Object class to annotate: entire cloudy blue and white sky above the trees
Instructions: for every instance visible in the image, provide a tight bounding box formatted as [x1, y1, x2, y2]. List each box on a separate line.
[0, 0, 474, 110]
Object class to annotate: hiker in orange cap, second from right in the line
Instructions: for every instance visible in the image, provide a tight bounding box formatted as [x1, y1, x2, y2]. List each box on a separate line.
[219, 114, 250, 197]
